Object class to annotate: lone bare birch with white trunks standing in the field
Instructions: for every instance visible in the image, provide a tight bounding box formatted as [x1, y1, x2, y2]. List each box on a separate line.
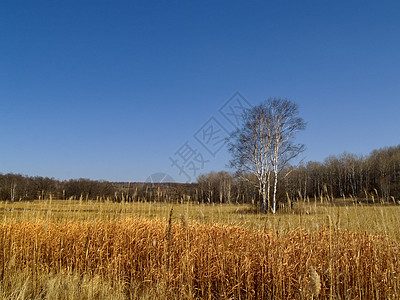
[229, 98, 305, 213]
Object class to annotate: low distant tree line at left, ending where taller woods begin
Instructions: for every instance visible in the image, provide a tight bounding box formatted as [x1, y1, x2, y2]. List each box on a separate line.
[0, 173, 207, 203]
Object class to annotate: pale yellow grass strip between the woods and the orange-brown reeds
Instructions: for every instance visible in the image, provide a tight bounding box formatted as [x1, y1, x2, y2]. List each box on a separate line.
[0, 200, 400, 241]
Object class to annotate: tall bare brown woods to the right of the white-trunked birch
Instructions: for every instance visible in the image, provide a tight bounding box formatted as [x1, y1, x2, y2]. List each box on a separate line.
[285, 145, 400, 201]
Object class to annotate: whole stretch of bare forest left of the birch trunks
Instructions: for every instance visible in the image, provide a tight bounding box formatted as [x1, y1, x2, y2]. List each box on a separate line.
[0, 171, 258, 203]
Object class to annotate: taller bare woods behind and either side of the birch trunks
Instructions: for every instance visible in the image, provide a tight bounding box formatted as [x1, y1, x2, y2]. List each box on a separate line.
[198, 145, 400, 206]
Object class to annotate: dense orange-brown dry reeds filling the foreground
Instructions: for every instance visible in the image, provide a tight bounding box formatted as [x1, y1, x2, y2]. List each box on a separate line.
[0, 219, 400, 299]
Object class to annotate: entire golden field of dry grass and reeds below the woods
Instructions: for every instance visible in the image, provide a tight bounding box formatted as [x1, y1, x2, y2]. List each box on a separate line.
[0, 200, 400, 299]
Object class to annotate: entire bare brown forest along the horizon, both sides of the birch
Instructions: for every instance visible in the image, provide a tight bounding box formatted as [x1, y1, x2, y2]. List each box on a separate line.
[0, 145, 400, 203]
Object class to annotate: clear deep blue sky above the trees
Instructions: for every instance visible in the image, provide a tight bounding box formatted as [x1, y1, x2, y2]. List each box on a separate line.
[0, 0, 400, 181]
